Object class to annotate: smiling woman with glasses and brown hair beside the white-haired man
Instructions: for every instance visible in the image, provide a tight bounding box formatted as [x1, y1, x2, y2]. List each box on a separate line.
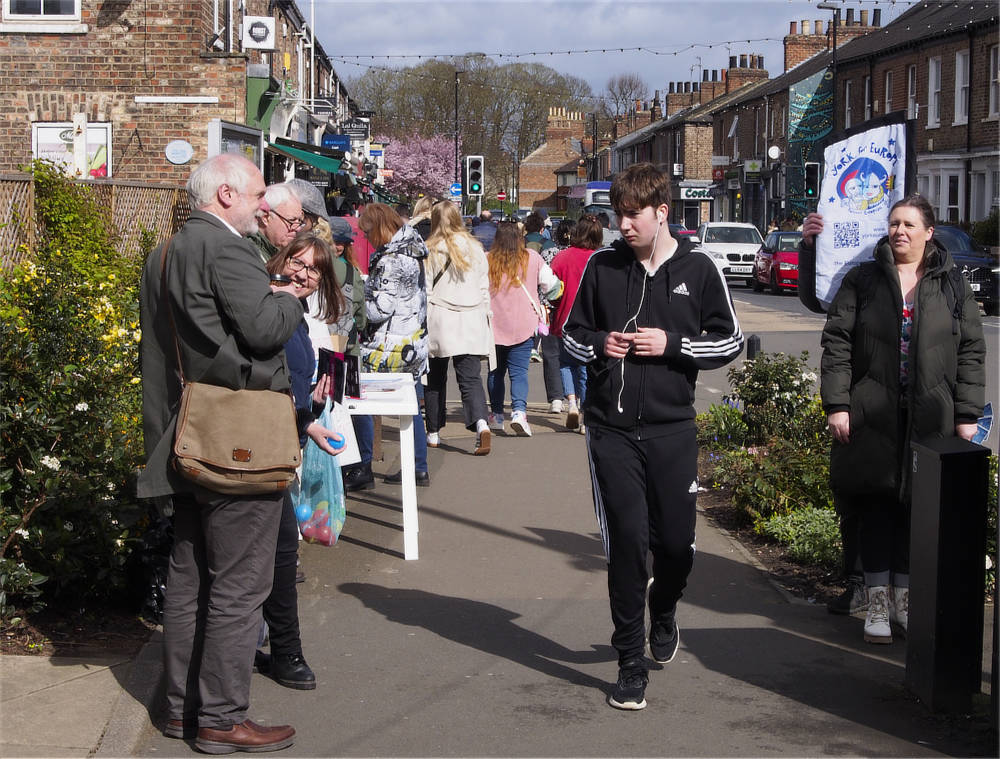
[254, 234, 344, 690]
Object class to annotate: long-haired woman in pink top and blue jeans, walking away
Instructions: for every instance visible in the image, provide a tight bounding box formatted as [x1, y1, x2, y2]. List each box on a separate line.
[486, 222, 562, 437]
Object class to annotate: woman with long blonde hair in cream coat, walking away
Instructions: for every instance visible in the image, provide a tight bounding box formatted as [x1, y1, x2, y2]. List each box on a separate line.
[424, 201, 493, 456]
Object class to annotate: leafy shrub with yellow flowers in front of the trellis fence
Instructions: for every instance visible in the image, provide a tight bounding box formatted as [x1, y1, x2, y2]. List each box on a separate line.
[0, 162, 144, 618]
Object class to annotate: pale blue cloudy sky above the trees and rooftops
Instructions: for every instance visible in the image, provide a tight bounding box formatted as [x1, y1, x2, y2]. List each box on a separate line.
[316, 0, 911, 101]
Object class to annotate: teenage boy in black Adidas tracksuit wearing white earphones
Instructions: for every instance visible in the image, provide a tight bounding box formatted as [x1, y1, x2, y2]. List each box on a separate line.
[563, 163, 743, 709]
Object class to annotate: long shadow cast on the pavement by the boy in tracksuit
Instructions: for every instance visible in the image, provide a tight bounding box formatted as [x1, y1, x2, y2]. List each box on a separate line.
[337, 583, 615, 693]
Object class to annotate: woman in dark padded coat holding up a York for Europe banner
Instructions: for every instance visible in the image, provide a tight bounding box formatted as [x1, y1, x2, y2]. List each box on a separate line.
[802, 195, 986, 644]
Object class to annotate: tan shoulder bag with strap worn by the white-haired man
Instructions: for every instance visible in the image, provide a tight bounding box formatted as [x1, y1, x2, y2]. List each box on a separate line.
[160, 238, 302, 495]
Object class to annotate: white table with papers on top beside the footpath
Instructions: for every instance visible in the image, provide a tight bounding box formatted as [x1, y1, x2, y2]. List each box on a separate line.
[344, 372, 420, 561]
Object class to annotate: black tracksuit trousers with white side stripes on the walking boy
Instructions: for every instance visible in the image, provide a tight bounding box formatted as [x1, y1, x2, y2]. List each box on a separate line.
[587, 424, 698, 663]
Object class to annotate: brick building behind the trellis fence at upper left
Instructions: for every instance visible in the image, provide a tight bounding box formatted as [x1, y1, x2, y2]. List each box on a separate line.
[0, 0, 351, 185]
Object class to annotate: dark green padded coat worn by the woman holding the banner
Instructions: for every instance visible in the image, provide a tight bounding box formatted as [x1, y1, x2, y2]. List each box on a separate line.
[820, 237, 986, 499]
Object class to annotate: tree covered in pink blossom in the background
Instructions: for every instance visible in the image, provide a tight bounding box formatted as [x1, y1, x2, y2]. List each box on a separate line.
[375, 134, 455, 199]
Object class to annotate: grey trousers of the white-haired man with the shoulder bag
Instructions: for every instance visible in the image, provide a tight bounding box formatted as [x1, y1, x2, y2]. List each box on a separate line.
[163, 491, 283, 728]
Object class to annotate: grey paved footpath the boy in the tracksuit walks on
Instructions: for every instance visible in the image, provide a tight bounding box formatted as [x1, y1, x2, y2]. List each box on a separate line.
[127, 394, 995, 757]
